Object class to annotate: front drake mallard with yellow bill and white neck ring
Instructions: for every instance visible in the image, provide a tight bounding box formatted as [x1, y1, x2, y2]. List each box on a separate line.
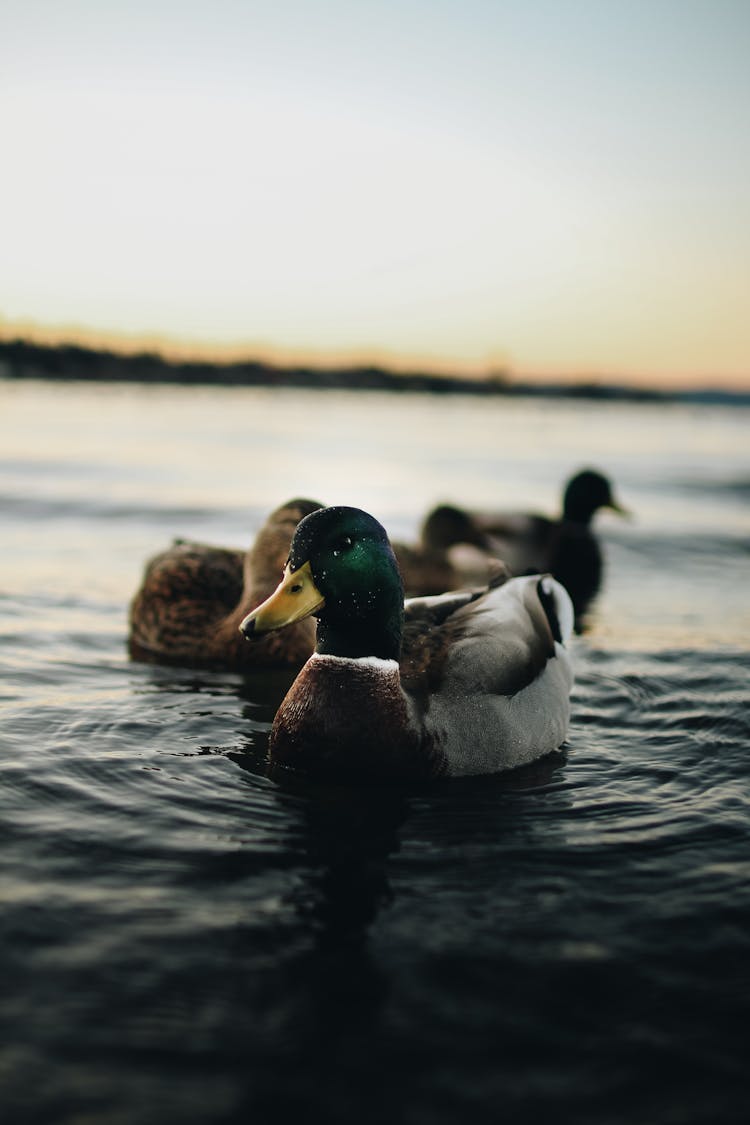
[240, 507, 572, 781]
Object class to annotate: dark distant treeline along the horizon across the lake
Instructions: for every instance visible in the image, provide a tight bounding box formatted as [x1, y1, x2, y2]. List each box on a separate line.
[0, 340, 749, 402]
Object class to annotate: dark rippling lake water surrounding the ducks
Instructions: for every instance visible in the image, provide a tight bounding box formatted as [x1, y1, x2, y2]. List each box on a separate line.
[0, 383, 750, 1125]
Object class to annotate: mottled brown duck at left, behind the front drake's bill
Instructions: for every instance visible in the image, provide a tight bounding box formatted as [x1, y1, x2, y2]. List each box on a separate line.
[128, 500, 320, 668]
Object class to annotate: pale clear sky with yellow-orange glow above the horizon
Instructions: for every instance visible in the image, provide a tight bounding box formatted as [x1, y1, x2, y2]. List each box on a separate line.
[0, 0, 750, 389]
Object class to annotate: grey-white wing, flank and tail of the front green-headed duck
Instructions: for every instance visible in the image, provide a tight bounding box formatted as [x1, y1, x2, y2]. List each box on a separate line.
[401, 576, 572, 774]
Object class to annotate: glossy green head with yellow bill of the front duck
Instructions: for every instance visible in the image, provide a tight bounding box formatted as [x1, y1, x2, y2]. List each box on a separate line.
[240, 507, 404, 659]
